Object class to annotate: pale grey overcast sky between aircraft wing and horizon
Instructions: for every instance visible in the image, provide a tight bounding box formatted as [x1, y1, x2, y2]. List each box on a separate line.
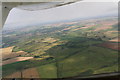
[4, 0, 118, 29]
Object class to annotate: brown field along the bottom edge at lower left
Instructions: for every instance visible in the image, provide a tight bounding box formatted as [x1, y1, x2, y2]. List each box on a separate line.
[5, 68, 40, 78]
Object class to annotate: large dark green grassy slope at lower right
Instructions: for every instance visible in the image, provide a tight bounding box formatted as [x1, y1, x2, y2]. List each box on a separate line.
[59, 47, 118, 77]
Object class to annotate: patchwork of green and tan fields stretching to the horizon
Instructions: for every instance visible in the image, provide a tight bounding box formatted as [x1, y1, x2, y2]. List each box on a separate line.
[2, 17, 120, 78]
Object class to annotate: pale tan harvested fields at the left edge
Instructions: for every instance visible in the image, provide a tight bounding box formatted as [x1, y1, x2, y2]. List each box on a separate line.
[0, 46, 33, 66]
